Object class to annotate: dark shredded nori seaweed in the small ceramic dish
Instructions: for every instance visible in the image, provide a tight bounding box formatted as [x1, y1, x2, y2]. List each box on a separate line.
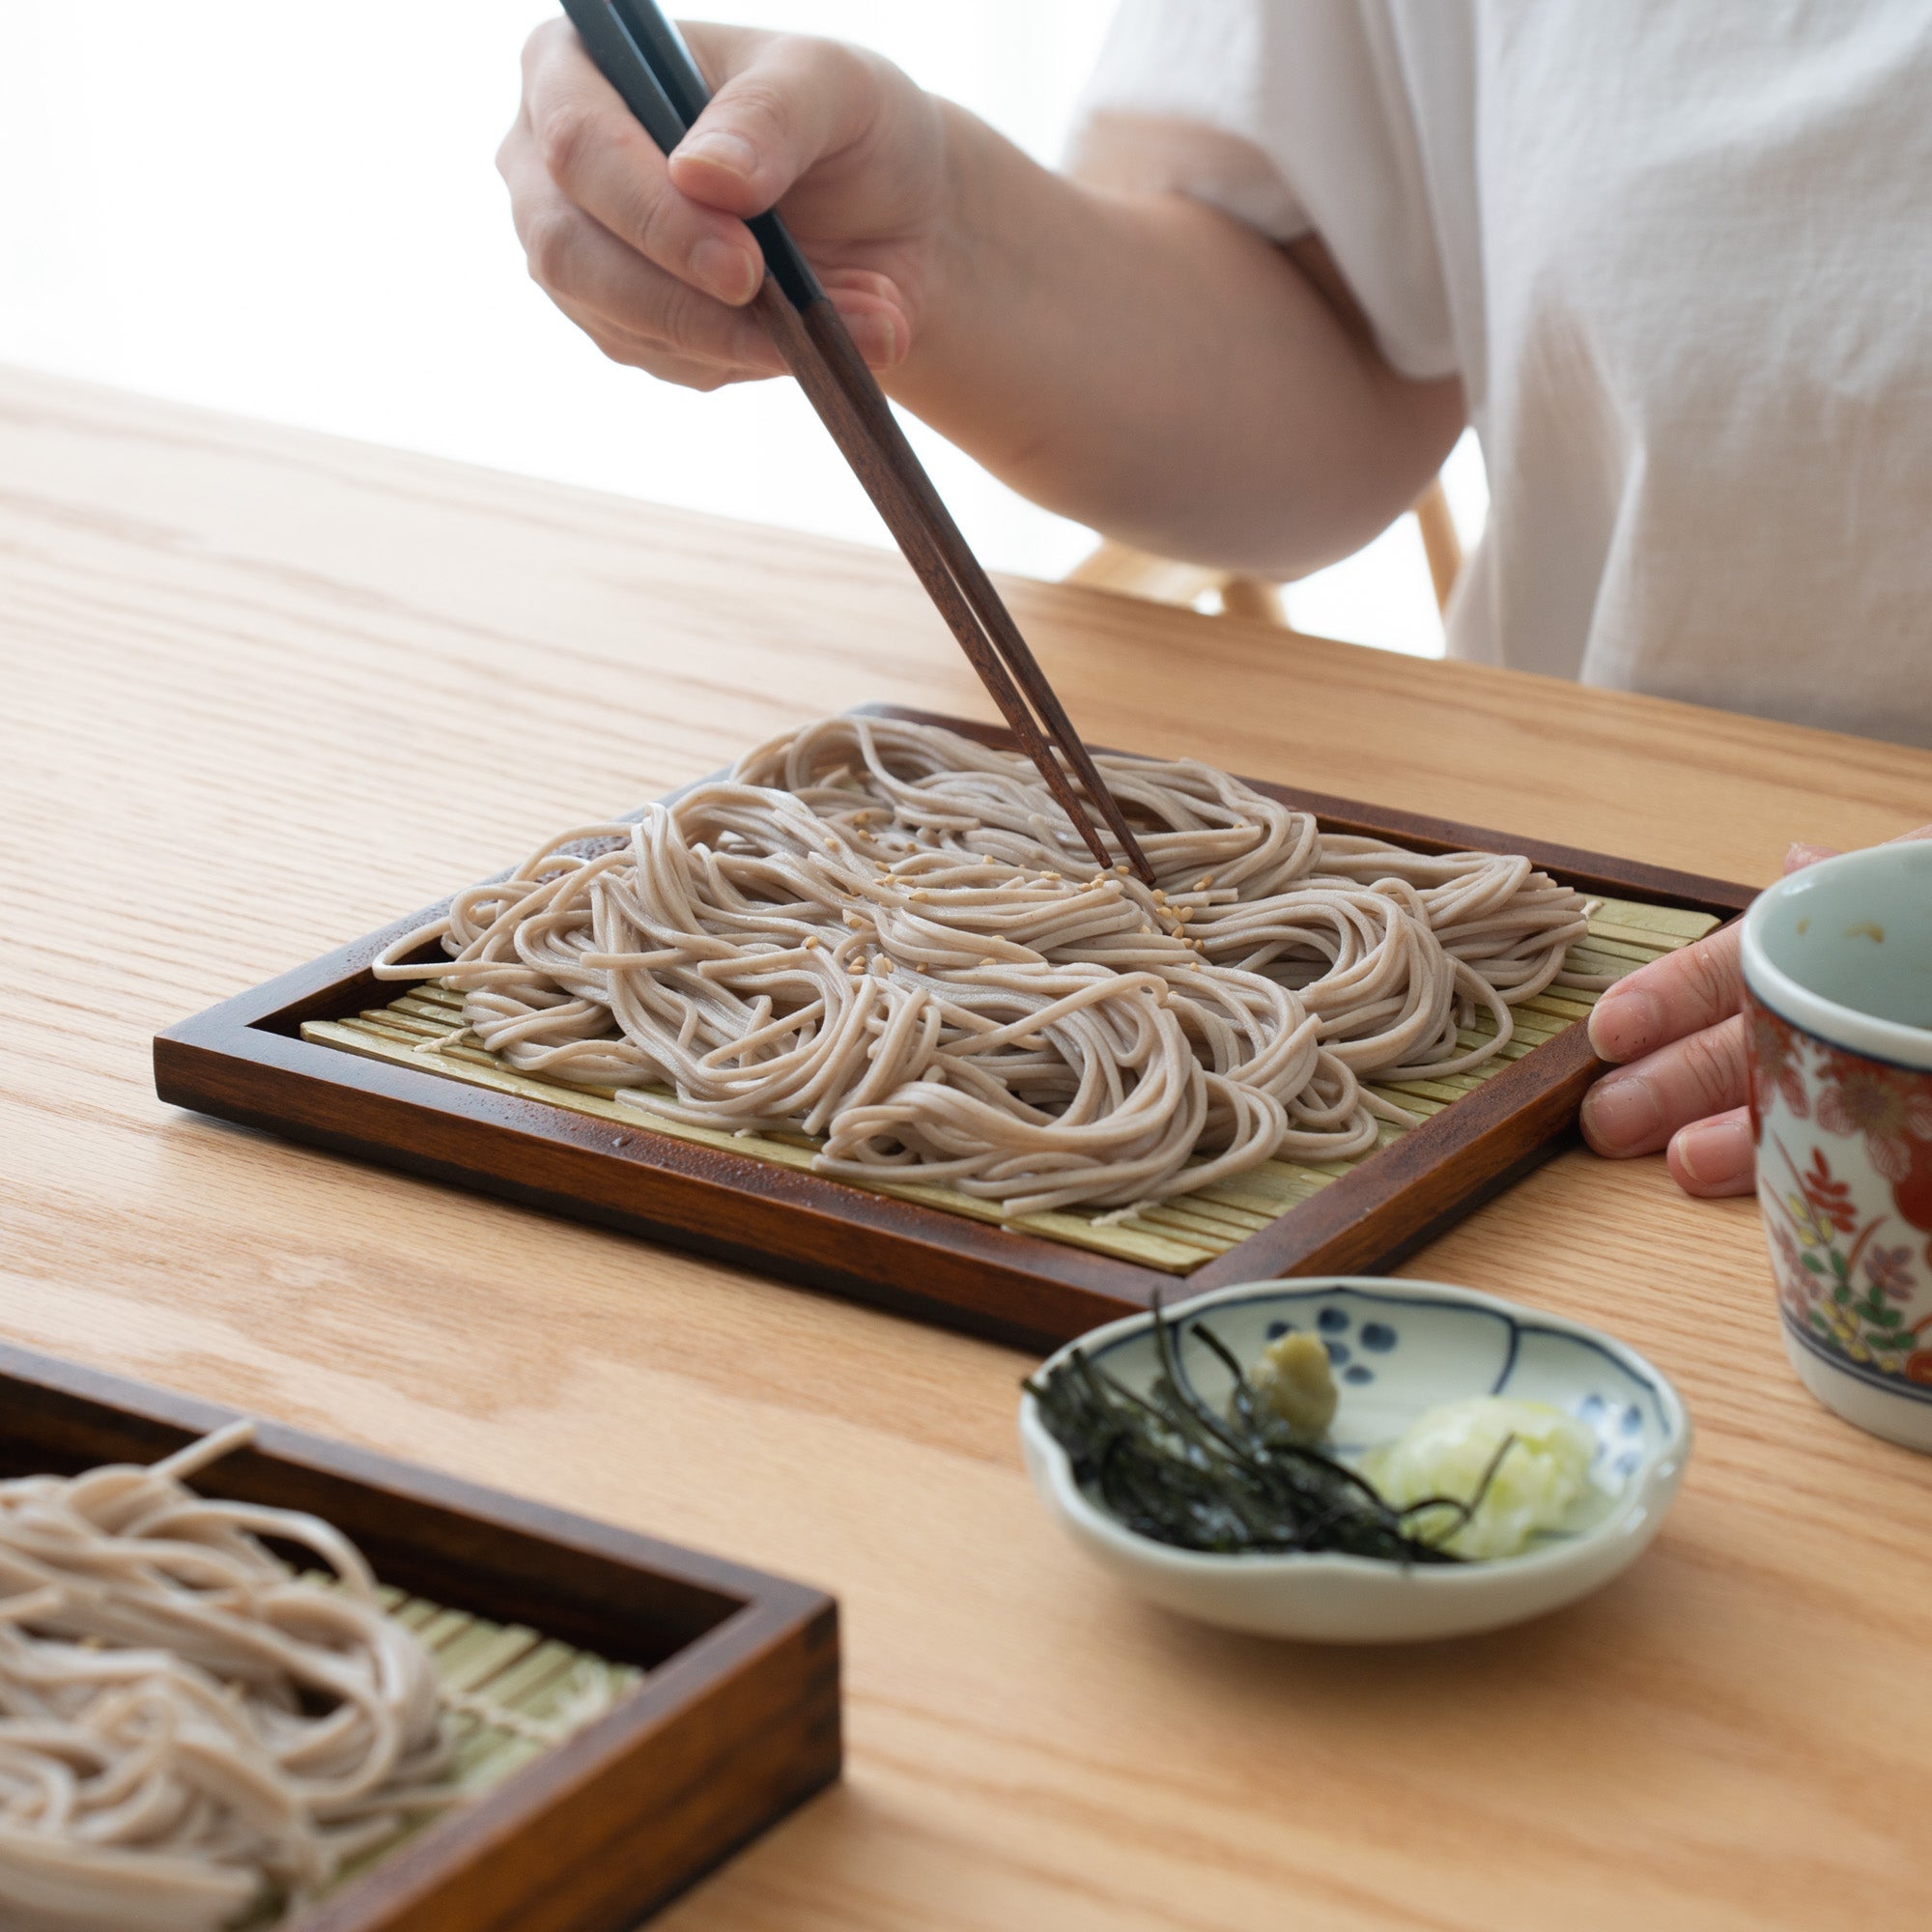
[1026, 1302, 1515, 1565]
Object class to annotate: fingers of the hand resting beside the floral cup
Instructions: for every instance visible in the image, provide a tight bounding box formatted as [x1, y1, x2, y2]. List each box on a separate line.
[1582, 825, 1932, 1196]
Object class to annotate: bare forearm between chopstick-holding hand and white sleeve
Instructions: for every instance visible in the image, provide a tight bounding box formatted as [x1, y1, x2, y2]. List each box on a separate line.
[887, 108, 1463, 578]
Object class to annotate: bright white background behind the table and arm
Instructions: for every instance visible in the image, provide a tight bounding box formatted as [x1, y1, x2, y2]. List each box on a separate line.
[0, 0, 1486, 653]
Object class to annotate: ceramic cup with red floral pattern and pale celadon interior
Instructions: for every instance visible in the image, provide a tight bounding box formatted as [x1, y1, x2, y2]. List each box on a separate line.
[1743, 842, 1932, 1449]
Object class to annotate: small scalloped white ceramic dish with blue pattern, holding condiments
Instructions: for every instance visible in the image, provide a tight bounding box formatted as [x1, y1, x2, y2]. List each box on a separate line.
[1020, 1277, 1690, 1644]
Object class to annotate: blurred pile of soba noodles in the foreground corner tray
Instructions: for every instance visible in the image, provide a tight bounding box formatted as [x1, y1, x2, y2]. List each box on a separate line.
[0, 1424, 450, 1932]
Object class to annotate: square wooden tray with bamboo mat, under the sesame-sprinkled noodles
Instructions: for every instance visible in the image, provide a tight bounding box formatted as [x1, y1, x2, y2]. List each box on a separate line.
[155, 705, 1752, 1347]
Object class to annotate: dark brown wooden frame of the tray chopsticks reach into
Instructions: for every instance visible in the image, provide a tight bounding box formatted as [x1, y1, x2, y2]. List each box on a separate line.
[155, 705, 1752, 1349]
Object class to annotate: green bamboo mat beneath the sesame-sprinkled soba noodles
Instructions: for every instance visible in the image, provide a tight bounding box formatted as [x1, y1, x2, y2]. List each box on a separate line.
[301, 898, 1718, 1275]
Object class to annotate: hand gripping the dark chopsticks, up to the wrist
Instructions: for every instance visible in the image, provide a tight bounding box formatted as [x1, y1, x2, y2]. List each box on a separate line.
[497, 19, 947, 390]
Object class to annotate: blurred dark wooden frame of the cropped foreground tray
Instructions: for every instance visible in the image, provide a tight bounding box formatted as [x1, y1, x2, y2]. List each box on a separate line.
[0, 1345, 840, 1932]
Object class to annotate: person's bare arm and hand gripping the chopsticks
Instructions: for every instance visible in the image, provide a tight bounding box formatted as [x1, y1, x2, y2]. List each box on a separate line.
[498, 19, 1463, 578]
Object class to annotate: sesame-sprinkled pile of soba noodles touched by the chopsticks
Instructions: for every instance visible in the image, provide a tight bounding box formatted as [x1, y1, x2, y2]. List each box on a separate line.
[375, 717, 1600, 1213]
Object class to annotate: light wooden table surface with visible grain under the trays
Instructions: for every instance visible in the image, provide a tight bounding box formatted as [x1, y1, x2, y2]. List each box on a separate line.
[0, 375, 1932, 1932]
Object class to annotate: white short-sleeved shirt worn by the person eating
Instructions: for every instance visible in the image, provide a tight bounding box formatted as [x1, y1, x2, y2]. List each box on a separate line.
[1072, 0, 1932, 746]
